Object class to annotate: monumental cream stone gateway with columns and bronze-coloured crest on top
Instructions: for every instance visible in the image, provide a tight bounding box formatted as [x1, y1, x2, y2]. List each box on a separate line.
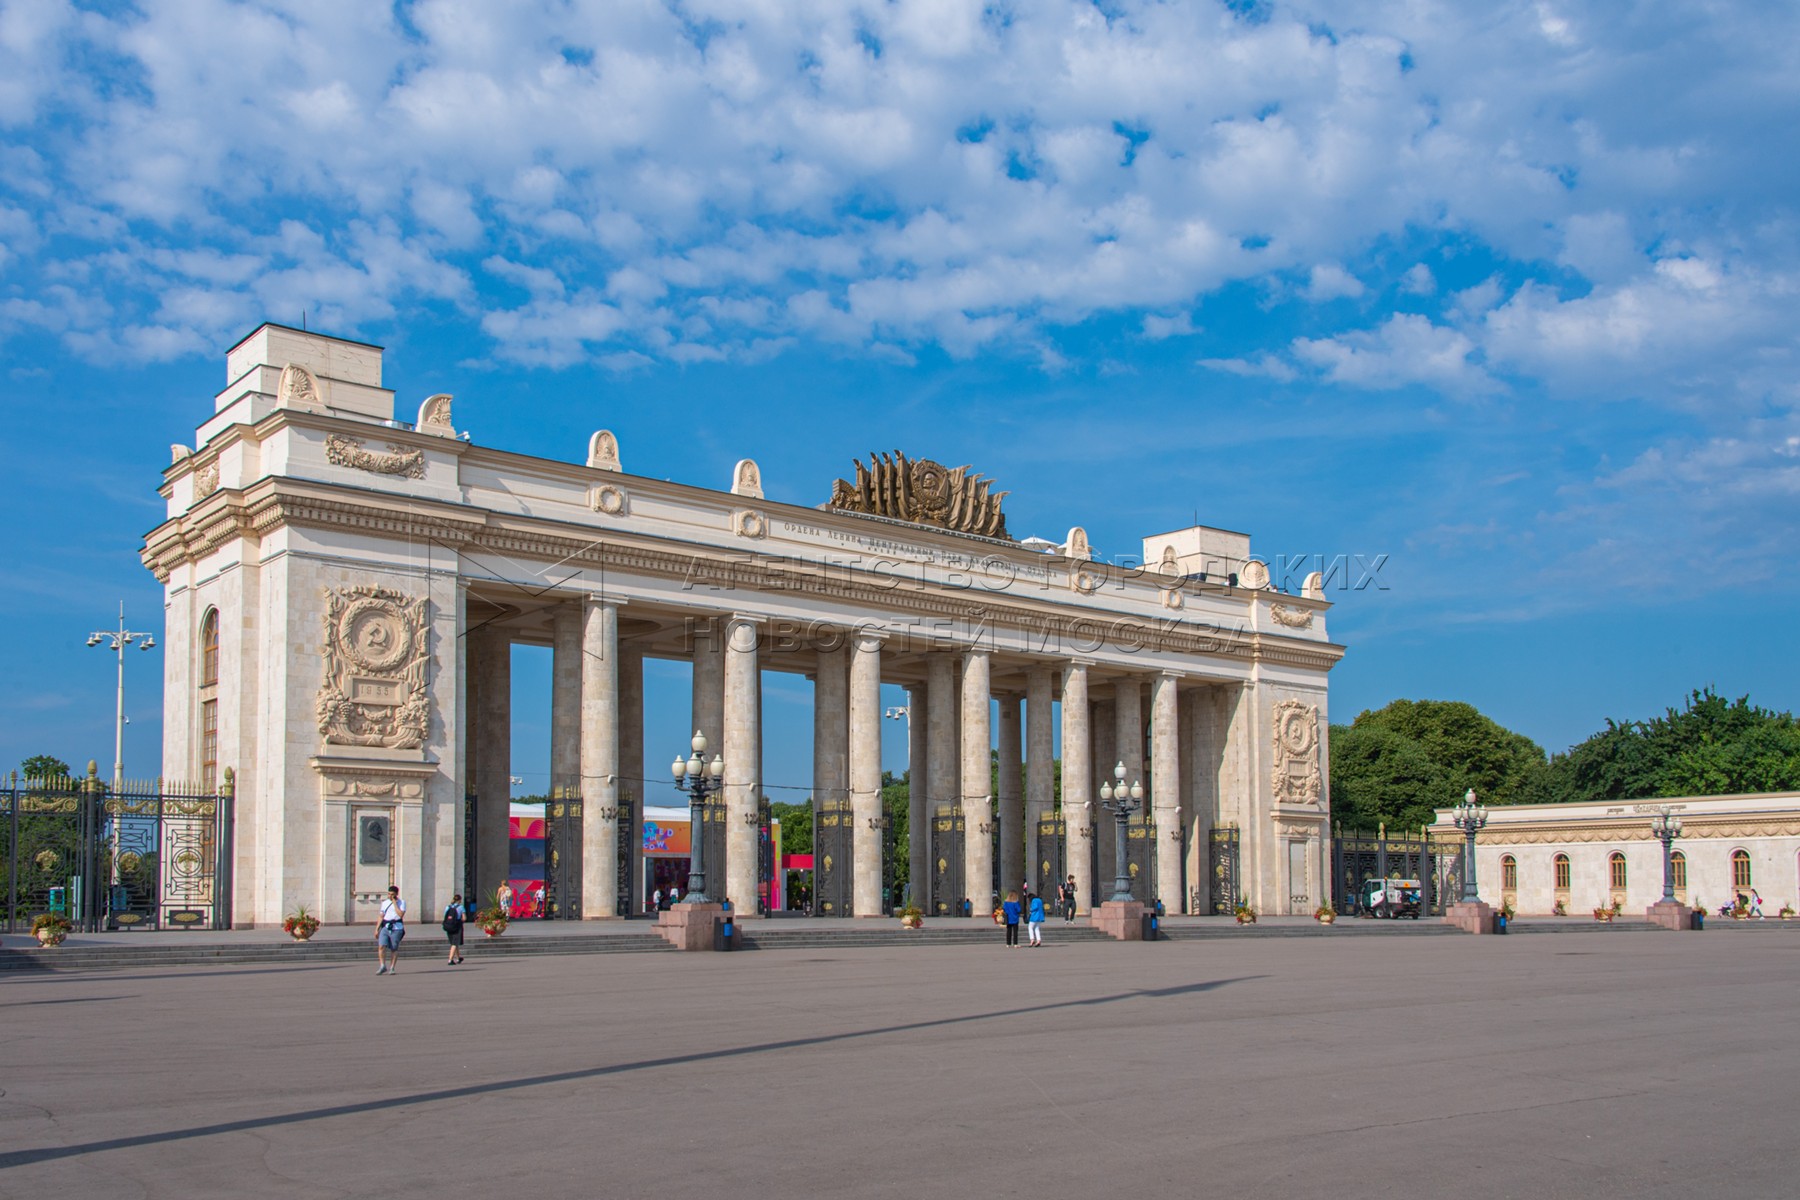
[142, 326, 1343, 925]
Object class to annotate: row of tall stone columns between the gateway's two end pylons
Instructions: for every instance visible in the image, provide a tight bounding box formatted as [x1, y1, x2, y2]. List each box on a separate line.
[466, 597, 1288, 919]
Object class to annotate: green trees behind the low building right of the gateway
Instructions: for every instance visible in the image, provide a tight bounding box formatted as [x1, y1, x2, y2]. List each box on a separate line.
[1330, 687, 1800, 829]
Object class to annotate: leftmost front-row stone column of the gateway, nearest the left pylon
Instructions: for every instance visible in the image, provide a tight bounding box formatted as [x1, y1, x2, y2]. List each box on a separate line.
[581, 599, 619, 921]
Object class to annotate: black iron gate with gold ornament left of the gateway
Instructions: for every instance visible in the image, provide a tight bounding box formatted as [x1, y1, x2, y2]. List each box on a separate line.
[0, 763, 232, 932]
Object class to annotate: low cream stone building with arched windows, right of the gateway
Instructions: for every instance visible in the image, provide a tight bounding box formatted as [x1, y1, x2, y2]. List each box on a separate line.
[1431, 792, 1800, 918]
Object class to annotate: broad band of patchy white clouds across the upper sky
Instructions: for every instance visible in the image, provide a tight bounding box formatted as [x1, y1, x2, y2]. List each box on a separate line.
[0, 0, 1800, 408]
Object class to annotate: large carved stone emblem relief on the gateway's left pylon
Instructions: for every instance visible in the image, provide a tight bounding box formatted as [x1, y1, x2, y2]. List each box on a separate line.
[319, 585, 430, 750]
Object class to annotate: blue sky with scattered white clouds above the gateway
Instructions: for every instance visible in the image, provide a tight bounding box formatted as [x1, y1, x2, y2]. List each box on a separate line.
[0, 0, 1800, 798]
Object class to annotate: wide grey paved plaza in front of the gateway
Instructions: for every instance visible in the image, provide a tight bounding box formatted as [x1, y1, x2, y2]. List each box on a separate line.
[0, 925, 1800, 1200]
